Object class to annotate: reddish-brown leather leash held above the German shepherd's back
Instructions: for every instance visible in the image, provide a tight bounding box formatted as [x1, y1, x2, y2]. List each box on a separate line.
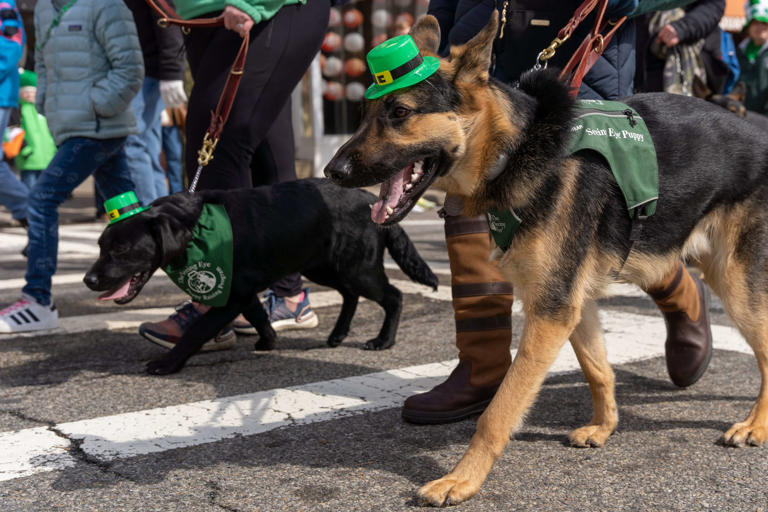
[536, 0, 627, 96]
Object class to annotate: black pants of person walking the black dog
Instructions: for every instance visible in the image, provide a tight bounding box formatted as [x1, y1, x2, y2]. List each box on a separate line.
[186, 0, 330, 297]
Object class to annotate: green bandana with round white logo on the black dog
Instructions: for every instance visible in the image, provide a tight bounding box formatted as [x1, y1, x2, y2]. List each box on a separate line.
[163, 203, 232, 306]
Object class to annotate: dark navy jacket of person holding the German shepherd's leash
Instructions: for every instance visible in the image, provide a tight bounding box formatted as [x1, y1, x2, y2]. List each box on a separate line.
[429, 0, 635, 99]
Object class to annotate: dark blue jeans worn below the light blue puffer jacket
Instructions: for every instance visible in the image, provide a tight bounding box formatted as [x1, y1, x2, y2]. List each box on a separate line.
[22, 137, 133, 305]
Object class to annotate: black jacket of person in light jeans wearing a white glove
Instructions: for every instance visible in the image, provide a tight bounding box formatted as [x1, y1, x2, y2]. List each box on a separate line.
[124, 0, 185, 80]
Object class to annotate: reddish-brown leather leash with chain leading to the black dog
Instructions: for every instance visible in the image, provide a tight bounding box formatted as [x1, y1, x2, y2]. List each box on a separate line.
[146, 0, 249, 192]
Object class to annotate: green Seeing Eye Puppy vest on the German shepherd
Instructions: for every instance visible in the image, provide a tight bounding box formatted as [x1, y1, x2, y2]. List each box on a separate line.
[485, 100, 659, 251]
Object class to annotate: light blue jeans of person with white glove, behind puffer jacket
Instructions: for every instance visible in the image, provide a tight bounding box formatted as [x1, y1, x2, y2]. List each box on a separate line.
[124, 77, 168, 205]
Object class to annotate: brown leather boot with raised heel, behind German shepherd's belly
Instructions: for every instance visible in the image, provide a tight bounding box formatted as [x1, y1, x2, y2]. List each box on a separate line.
[646, 262, 712, 388]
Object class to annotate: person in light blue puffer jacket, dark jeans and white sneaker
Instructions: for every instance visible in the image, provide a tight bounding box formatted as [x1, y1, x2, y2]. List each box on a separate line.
[0, 0, 144, 333]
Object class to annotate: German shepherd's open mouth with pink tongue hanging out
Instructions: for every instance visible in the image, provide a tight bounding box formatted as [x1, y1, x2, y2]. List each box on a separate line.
[371, 158, 438, 224]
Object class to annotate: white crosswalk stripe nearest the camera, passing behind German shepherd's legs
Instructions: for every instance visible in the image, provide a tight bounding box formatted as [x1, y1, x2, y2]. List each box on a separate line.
[0, 312, 751, 481]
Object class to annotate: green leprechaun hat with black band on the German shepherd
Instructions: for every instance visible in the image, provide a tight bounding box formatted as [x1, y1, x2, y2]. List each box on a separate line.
[365, 35, 440, 100]
